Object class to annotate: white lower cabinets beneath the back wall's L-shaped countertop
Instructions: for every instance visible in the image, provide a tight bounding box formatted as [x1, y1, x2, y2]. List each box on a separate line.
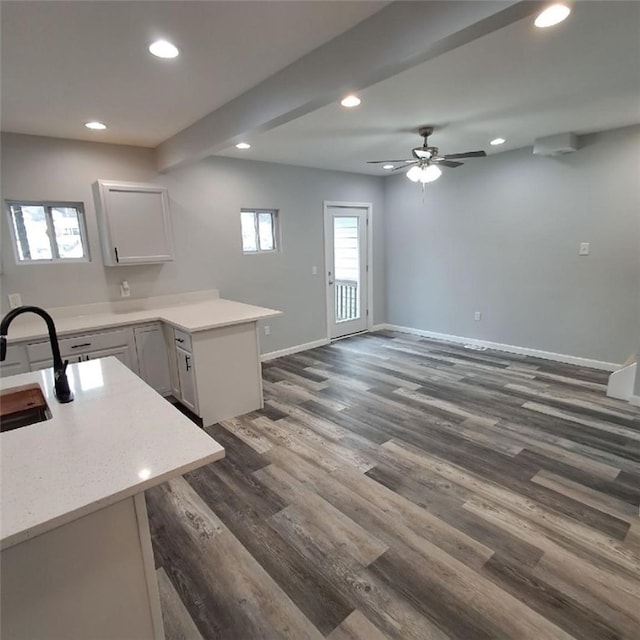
[5, 321, 263, 425]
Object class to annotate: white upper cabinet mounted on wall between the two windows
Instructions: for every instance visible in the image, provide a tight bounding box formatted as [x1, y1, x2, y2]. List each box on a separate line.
[93, 180, 173, 267]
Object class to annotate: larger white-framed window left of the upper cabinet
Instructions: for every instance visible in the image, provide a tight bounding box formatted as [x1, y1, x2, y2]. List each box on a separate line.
[7, 202, 89, 264]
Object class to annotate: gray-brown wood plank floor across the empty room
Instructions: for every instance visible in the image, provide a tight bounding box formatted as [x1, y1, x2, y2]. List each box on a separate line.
[147, 332, 640, 640]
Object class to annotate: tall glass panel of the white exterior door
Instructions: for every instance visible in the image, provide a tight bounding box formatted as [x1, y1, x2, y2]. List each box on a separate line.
[333, 216, 360, 322]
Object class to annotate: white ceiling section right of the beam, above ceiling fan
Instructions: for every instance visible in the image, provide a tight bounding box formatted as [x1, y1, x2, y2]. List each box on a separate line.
[218, 1, 640, 175]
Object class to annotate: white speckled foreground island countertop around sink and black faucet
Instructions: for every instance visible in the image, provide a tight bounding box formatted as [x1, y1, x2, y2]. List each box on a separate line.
[0, 358, 224, 549]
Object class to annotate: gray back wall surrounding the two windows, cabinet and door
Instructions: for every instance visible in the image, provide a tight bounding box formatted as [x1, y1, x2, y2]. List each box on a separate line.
[1, 134, 385, 352]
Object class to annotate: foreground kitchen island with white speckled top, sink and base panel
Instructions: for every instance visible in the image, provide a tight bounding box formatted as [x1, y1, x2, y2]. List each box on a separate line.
[0, 357, 224, 640]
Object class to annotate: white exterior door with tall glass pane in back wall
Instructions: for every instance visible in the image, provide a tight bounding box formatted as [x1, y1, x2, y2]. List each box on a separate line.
[324, 203, 369, 339]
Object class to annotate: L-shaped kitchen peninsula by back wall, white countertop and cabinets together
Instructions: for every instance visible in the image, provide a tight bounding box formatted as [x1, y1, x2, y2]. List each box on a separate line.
[1, 290, 280, 425]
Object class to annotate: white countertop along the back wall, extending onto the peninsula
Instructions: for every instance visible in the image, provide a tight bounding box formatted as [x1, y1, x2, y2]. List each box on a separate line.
[3, 298, 282, 344]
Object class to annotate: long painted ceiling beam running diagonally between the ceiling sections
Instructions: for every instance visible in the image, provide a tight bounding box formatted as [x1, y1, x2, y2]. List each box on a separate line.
[156, 0, 541, 171]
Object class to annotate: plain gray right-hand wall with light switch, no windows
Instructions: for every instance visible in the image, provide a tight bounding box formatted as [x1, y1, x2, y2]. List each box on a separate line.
[385, 126, 640, 362]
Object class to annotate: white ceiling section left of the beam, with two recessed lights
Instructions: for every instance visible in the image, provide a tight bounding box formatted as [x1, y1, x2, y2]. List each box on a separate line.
[1, 0, 388, 147]
